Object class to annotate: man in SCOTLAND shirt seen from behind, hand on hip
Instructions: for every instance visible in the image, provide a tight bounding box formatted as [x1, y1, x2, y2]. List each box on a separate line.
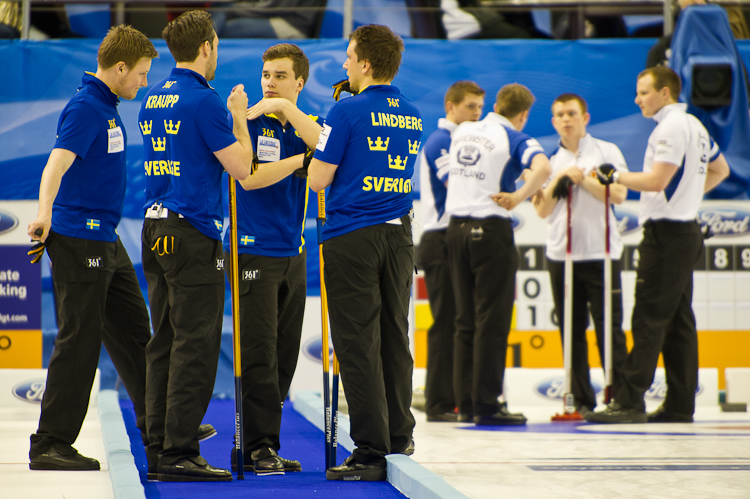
[445, 83, 550, 425]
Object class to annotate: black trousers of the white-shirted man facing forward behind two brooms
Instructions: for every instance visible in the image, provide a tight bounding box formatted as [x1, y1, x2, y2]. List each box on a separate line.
[547, 259, 628, 409]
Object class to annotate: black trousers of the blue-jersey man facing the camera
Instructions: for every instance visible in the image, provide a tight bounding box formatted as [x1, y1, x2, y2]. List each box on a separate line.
[224, 250, 307, 457]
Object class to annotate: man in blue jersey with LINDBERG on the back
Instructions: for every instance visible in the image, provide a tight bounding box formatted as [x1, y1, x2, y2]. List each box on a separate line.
[309, 25, 422, 481]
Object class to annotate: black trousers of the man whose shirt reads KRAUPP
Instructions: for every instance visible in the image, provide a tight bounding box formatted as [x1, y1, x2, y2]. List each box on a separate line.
[141, 218, 224, 470]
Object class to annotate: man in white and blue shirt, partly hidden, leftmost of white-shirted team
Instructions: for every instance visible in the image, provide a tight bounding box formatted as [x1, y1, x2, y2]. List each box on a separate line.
[417, 81, 485, 422]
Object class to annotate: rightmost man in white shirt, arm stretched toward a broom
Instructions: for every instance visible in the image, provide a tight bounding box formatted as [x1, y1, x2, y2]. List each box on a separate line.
[586, 66, 729, 423]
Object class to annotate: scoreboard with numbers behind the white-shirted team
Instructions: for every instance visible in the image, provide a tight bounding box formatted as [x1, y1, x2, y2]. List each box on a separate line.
[411, 201, 750, 388]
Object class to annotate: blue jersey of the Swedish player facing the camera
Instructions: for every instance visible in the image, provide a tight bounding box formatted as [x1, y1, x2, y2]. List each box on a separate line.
[224, 114, 323, 257]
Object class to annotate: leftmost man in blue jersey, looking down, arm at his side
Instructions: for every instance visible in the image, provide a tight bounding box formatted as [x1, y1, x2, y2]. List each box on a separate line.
[28, 25, 158, 470]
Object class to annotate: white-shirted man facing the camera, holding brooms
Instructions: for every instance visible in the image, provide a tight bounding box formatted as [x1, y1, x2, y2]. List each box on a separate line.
[533, 93, 628, 416]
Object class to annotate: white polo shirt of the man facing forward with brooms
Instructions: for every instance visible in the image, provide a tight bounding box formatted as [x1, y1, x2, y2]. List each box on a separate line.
[546, 134, 628, 261]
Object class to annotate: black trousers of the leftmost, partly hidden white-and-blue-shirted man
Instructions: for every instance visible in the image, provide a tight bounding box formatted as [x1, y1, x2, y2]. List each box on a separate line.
[417, 229, 456, 415]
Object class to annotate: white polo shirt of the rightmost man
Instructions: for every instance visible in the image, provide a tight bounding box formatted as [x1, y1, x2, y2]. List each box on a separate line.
[638, 104, 720, 225]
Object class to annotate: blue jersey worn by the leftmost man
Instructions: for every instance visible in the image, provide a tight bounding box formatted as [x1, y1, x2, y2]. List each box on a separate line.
[52, 73, 127, 242]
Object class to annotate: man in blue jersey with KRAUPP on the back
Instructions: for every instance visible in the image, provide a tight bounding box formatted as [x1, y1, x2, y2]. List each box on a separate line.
[138, 11, 252, 481]
